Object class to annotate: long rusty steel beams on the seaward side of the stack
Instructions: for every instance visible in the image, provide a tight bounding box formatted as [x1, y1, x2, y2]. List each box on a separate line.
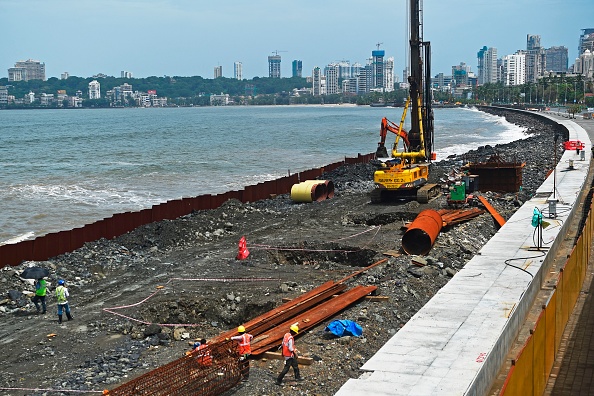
[211, 281, 346, 342]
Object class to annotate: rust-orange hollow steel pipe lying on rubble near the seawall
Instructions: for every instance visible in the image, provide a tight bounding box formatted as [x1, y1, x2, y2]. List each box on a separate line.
[402, 209, 443, 255]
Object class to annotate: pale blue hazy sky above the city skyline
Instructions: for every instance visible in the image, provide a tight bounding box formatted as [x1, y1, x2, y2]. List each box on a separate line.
[0, 0, 594, 79]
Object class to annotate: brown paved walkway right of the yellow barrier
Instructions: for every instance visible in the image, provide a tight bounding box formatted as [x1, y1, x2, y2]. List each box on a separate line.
[545, 115, 594, 396]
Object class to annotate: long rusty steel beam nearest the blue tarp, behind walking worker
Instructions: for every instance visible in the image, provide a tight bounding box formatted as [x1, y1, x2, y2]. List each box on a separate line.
[252, 286, 377, 355]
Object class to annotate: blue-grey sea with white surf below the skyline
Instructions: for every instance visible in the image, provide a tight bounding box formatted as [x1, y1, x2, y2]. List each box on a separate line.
[0, 105, 525, 244]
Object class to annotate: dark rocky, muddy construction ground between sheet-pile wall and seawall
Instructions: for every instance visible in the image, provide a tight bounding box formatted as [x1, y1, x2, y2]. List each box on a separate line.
[0, 108, 561, 395]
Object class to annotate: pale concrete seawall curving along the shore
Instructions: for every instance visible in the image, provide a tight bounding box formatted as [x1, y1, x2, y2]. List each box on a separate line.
[337, 109, 592, 395]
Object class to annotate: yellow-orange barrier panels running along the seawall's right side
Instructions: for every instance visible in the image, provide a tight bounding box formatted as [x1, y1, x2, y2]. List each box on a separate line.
[500, 201, 594, 395]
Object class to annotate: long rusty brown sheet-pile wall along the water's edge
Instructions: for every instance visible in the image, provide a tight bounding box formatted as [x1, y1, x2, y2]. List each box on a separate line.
[0, 153, 375, 268]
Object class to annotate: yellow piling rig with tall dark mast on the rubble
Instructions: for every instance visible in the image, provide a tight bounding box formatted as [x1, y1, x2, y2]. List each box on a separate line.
[371, 0, 441, 203]
